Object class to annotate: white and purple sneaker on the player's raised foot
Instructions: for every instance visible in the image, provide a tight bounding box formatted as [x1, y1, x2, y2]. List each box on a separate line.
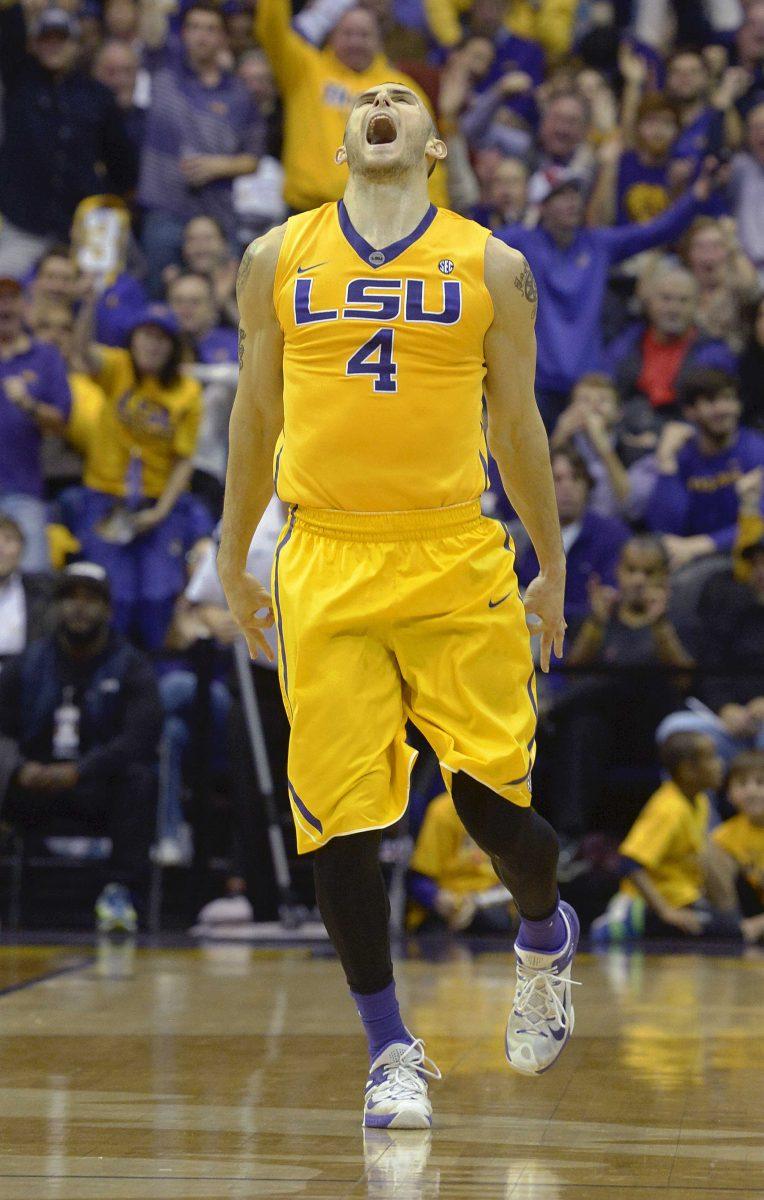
[506, 900, 579, 1075]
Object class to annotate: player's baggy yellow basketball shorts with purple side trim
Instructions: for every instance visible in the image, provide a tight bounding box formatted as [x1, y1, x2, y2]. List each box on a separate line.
[271, 503, 537, 853]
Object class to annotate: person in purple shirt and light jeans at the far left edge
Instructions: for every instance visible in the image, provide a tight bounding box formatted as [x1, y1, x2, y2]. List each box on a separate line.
[0, 277, 72, 571]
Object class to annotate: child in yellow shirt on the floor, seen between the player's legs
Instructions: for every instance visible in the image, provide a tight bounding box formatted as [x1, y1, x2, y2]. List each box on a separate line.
[407, 792, 512, 932]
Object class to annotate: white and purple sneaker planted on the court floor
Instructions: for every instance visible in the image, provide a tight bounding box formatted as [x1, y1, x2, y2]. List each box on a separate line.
[363, 1038, 440, 1129]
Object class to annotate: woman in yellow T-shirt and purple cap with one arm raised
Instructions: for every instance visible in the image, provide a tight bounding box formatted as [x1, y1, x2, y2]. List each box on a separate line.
[47, 301, 212, 650]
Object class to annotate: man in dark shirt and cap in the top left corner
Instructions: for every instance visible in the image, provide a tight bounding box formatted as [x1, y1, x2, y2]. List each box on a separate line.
[0, 2, 137, 275]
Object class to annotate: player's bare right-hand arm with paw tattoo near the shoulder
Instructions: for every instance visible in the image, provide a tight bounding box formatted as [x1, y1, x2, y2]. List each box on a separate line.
[485, 238, 565, 671]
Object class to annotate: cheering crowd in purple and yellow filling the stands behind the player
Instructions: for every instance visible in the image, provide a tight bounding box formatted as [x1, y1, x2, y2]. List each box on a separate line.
[0, 0, 764, 928]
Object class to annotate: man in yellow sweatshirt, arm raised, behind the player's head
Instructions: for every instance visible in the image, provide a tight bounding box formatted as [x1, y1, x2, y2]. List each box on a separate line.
[255, 0, 449, 212]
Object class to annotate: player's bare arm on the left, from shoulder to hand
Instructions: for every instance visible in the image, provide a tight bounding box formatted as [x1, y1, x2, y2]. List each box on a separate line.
[217, 226, 285, 659]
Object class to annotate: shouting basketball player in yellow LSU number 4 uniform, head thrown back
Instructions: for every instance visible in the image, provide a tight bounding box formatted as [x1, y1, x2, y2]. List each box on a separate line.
[218, 84, 578, 1128]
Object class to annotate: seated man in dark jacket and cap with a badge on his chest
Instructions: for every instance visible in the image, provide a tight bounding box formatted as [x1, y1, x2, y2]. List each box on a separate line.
[0, 563, 162, 928]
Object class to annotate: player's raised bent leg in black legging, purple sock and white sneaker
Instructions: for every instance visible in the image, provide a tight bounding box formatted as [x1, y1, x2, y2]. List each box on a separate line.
[452, 773, 579, 1075]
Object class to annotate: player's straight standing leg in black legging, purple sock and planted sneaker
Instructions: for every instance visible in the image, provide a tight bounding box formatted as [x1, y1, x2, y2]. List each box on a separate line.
[313, 830, 440, 1129]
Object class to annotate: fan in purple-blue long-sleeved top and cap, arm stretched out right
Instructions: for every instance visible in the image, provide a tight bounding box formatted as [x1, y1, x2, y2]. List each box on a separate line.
[497, 153, 718, 428]
